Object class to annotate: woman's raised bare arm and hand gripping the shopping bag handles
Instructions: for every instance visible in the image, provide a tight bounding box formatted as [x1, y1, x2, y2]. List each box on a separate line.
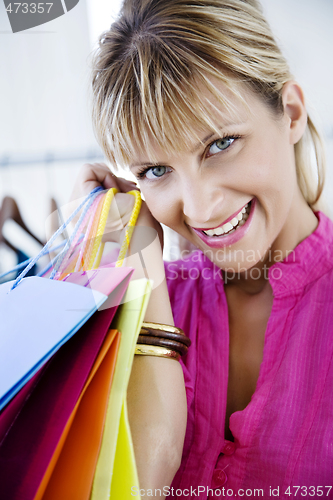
[72, 164, 187, 498]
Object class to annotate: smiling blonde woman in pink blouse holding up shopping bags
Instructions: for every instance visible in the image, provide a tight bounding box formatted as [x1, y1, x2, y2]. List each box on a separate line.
[71, 0, 333, 499]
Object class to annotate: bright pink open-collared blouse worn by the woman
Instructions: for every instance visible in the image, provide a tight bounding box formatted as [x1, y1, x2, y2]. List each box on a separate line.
[166, 212, 333, 500]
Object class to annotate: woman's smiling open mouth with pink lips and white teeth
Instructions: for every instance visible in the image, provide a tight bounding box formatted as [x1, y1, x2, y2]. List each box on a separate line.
[192, 198, 256, 248]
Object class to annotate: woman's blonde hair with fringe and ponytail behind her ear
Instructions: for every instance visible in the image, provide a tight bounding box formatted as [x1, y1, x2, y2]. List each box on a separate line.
[92, 0, 324, 207]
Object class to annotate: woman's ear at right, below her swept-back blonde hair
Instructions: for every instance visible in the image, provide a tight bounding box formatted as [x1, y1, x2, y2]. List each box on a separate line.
[282, 81, 308, 144]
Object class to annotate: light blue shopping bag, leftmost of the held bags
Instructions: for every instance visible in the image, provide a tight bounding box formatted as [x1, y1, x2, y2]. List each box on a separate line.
[0, 268, 132, 410]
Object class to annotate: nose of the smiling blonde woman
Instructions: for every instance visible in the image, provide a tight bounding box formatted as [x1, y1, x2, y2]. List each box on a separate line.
[182, 179, 224, 227]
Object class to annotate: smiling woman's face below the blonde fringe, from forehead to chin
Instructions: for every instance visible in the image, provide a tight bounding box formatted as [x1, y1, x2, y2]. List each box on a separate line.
[131, 78, 309, 272]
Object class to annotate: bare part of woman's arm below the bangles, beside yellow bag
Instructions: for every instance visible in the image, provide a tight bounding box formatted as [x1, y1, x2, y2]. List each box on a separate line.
[127, 356, 186, 498]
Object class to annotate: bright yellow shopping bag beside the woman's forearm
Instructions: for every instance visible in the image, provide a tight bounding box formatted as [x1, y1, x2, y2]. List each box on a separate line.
[91, 279, 152, 500]
